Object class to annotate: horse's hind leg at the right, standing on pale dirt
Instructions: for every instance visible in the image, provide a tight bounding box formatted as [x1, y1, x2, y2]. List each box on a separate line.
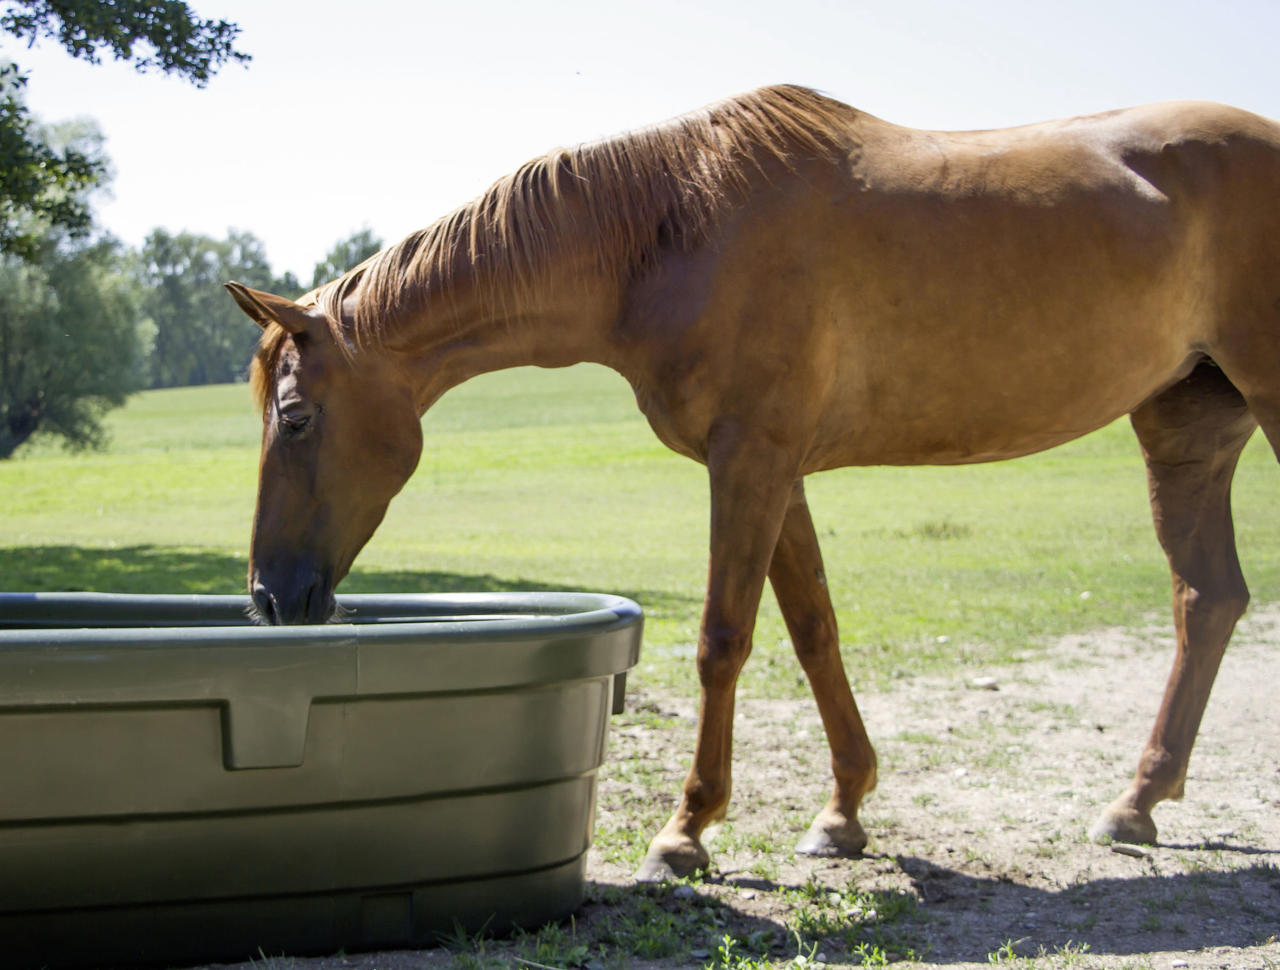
[1091, 362, 1256, 842]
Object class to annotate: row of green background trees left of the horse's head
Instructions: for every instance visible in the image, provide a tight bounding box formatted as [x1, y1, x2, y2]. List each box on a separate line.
[0, 123, 381, 459]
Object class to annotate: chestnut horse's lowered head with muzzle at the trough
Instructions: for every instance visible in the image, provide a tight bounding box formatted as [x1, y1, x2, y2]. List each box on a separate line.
[227, 283, 422, 623]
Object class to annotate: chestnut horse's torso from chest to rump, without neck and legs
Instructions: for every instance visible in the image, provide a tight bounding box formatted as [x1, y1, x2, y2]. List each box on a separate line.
[616, 94, 1280, 471]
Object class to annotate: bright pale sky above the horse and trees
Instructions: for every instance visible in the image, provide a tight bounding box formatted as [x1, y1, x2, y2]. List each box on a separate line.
[10, 0, 1280, 283]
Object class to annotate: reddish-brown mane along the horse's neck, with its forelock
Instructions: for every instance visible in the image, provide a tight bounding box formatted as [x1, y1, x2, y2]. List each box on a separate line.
[253, 84, 854, 399]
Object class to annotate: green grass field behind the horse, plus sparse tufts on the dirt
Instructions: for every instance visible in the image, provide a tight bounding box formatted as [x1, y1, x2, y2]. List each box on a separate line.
[0, 367, 1280, 970]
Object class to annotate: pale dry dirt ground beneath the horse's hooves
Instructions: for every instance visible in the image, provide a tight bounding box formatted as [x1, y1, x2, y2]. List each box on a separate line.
[204, 608, 1280, 970]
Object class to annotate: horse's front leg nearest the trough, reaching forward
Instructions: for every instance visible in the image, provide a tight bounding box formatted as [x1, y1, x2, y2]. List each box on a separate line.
[636, 429, 795, 882]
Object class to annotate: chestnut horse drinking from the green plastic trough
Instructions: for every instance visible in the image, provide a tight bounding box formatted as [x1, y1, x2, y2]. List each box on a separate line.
[228, 87, 1280, 879]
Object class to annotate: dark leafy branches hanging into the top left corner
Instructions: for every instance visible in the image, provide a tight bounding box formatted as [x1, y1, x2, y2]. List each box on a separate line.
[0, 0, 248, 256]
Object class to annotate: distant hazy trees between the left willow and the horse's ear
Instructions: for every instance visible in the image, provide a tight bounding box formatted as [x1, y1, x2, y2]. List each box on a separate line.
[141, 229, 297, 388]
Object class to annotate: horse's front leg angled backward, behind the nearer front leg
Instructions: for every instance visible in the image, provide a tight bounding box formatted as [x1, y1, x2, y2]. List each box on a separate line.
[769, 481, 876, 855]
